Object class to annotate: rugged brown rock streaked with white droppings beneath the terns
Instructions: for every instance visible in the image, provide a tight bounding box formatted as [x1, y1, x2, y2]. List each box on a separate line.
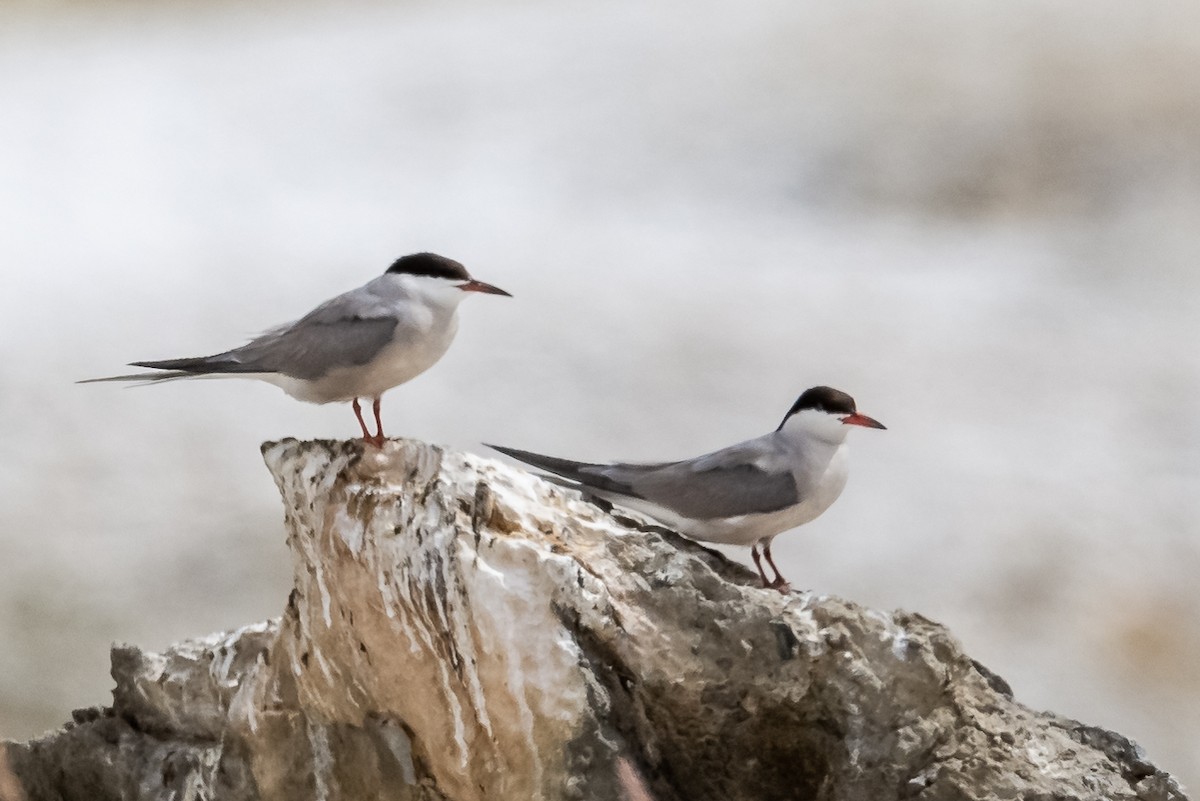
[0, 440, 1184, 801]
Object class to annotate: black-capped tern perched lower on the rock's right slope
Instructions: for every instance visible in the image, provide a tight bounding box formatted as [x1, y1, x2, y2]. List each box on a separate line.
[490, 386, 883, 592]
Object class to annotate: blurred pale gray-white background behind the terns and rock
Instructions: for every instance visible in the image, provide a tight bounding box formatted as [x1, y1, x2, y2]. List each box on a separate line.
[0, 0, 1200, 787]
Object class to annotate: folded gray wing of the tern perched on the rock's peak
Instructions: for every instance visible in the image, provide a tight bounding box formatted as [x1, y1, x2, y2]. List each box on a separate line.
[126, 289, 397, 380]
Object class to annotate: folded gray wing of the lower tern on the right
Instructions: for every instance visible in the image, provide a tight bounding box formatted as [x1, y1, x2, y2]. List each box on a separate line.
[491, 440, 800, 520]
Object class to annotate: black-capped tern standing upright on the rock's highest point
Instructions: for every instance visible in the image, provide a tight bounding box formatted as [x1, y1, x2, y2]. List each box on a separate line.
[80, 253, 510, 446]
